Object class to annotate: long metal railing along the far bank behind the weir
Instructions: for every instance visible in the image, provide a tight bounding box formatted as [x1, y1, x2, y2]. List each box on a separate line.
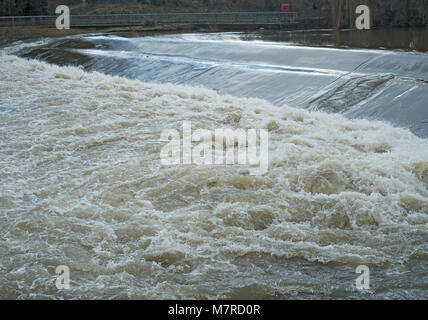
[0, 12, 300, 27]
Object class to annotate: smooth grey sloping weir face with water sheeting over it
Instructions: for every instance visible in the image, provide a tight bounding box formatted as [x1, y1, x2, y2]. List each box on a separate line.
[20, 33, 428, 137]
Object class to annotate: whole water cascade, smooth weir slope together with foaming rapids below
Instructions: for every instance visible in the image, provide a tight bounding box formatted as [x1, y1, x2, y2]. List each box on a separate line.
[0, 35, 428, 299]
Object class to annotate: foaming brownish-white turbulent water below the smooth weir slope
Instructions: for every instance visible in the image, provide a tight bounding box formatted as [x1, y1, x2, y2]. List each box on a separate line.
[0, 50, 428, 299]
